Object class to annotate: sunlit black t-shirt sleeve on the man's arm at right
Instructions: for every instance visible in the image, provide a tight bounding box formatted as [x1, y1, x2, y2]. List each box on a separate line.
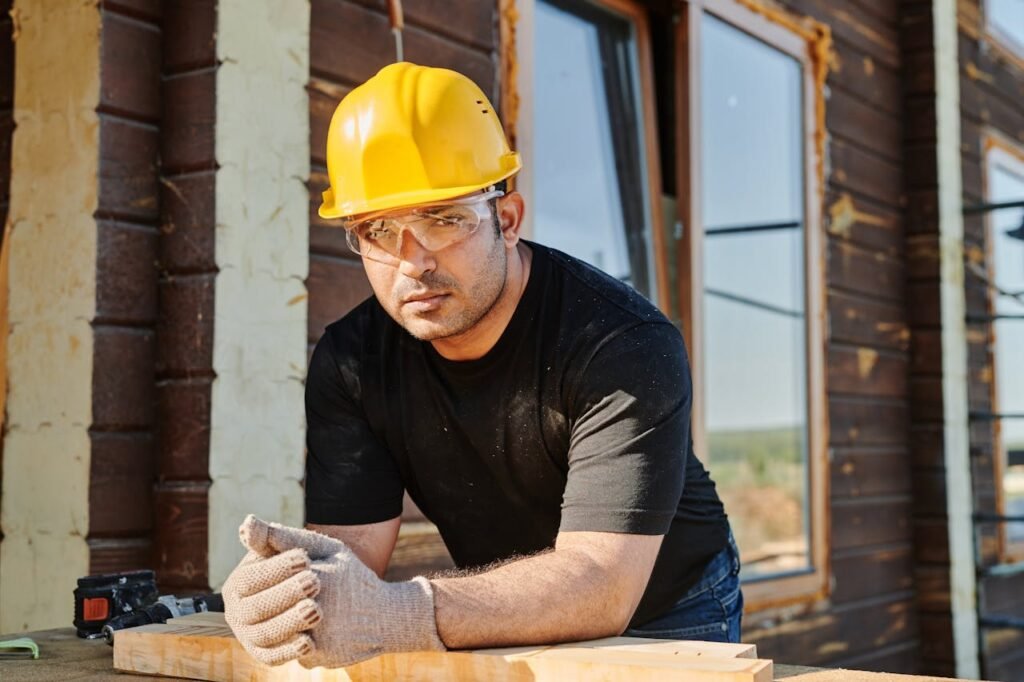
[560, 323, 691, 535]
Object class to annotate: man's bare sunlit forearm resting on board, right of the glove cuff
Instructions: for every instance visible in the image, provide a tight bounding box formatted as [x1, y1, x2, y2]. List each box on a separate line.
[431, 534, 660, 649]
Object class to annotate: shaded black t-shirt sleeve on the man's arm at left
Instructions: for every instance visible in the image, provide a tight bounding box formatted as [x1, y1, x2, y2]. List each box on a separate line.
[305, 329, 403, 525]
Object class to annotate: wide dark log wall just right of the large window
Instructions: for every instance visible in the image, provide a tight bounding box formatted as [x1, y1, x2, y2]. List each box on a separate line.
[712, 0, 923, 672]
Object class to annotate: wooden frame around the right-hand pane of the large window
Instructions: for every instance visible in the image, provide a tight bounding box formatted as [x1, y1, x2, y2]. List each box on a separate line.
[676, 0, 830, 612]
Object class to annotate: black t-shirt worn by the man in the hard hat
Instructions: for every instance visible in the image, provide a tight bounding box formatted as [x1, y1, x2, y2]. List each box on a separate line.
[305, 244, 728, 625]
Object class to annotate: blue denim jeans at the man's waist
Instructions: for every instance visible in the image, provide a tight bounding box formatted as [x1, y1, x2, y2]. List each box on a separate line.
[624, 532, 743, 642]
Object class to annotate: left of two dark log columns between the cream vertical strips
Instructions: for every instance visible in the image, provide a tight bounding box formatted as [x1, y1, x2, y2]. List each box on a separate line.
[87, 0, 161, 572]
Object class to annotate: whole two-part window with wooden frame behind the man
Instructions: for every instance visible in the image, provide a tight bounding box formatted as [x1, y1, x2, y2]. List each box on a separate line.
[502, 0, 828, 610]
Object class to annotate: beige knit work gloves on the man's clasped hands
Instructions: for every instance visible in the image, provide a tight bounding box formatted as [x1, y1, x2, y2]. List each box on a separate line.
[224, 515, 444, 668]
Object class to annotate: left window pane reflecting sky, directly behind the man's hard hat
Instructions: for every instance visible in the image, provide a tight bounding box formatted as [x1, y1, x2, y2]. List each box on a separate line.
[525, 0, 665, 301]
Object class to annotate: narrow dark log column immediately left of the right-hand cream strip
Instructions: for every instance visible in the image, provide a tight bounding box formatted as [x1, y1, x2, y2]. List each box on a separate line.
[901, 0, 966, 676]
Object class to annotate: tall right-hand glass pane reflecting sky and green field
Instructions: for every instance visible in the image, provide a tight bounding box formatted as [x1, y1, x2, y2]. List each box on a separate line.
[700, 13, 811, 579]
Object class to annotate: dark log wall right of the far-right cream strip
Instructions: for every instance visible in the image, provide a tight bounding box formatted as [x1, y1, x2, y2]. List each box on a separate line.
[957, 0, 1024, 680]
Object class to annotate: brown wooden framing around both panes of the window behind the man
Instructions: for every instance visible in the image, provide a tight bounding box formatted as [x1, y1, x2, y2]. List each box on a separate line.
[499, 0, 831, 613]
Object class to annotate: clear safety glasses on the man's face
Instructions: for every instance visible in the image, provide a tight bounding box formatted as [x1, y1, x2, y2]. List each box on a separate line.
[344, 189, 505, 265]
